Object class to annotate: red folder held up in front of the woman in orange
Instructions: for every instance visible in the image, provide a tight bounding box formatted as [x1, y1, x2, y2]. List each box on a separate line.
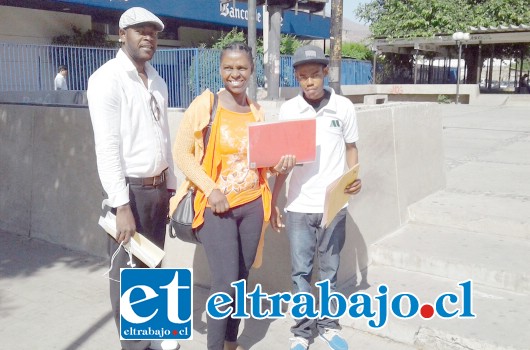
[247, 118, 317, 168]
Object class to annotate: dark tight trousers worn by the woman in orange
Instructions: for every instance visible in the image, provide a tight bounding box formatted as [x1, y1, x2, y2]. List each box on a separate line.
[199, 197, 263, 350]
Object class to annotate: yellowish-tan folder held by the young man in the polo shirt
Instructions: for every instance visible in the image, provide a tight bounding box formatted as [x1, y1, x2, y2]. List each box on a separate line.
[320, 163, 359, 228]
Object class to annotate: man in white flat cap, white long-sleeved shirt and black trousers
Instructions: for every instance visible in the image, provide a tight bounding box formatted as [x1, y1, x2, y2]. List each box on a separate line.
[87, 7, 178, 350]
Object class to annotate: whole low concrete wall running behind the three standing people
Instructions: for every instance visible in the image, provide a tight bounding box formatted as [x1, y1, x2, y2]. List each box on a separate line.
[0, 103, 445, 291]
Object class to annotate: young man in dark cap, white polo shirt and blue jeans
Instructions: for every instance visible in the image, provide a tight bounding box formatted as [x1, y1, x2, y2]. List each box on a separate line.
[271, 45, 361, 350]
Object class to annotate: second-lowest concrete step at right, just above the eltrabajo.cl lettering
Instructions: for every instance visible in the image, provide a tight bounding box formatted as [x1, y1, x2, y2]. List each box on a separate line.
[371, 223, 530, 293]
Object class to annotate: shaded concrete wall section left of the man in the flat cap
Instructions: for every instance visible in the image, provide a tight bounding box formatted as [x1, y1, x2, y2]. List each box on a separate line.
[0, 104, 107, 256]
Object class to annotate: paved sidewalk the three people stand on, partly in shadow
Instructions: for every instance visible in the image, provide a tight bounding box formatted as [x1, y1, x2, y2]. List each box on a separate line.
[0, 231, 412, 350]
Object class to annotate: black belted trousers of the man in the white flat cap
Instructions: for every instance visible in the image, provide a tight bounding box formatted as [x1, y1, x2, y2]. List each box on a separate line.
[108, 183, 169, 350]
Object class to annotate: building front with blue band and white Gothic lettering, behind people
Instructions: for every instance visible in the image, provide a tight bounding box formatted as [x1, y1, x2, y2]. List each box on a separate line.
[0, 0, 330, 47]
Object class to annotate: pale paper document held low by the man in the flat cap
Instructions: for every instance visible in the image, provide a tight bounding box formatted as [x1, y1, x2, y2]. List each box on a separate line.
[98, 205, 165, 267]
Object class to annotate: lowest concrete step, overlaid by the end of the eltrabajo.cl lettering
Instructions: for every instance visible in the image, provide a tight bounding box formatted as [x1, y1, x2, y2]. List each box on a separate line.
[341, 266, 530, 350]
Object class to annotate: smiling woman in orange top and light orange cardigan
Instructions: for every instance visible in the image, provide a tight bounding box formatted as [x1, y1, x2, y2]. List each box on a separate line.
[171, 42, 295, 350]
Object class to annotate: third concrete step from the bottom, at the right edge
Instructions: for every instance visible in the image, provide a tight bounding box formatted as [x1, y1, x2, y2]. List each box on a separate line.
[409, 191, 530, 240]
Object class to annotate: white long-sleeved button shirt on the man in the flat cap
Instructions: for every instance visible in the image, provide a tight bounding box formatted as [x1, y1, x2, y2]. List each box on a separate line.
[87, 50, 176, 207]
